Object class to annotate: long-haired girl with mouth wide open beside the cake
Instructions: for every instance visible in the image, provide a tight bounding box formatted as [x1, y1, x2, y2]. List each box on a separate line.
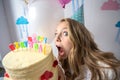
[55, 18, 120, 80]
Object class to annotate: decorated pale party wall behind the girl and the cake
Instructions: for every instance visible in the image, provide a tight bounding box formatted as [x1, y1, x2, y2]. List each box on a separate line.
[0, 0, 120, 67]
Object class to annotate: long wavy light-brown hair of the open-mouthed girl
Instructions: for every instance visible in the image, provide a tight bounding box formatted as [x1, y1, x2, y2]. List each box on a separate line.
[60, 18, 120, 80]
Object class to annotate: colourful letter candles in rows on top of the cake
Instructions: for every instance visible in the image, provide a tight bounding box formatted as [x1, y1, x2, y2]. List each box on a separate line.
[9, 35, 47, 54]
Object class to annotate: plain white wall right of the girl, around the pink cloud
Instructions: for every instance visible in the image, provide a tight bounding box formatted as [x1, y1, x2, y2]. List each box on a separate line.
[65, 0, 120, 59]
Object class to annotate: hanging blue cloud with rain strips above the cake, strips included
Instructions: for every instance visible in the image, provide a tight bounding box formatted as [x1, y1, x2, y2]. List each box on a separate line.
[16, 0, 30, 41]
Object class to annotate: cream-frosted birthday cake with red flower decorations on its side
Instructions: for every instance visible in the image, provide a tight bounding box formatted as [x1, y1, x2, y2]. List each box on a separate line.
[2, 36, 58, 80]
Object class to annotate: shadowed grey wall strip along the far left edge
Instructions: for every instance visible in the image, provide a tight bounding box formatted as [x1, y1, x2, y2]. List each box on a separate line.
[0, 0, 10, 67]
